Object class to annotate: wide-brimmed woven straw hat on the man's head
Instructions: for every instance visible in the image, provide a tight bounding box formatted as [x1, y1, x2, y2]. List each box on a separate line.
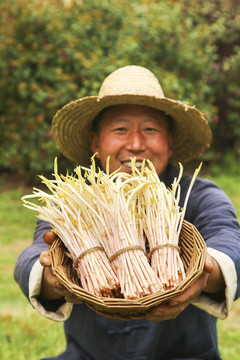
[52, 65, 212, 166]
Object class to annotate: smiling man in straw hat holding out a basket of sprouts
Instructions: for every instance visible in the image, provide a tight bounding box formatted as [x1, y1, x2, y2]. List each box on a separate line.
[15, 66, 240, 360]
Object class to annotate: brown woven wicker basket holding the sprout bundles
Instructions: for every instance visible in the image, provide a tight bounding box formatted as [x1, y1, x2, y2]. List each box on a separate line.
[50, 221, 206, 320]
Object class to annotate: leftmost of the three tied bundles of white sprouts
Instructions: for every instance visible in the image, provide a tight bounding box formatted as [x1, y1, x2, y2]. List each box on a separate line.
[23, 159, 119, 296]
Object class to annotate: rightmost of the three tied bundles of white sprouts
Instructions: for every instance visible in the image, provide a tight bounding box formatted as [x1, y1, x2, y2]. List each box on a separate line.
[126, 161, 201, 289]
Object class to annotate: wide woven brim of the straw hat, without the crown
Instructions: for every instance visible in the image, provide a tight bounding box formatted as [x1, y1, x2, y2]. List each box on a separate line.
[52, 94, 212, 166]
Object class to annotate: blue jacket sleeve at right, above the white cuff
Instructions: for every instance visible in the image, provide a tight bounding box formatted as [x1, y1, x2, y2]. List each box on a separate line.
[186, 179, 240, 299]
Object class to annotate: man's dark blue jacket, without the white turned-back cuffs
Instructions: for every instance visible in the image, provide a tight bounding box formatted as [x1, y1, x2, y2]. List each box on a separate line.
[15, 165, 240, 360]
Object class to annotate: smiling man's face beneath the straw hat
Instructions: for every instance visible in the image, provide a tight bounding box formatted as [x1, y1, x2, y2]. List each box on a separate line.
[91, 105, 173, 175]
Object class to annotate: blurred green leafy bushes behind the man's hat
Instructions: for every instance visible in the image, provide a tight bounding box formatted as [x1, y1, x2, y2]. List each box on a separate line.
[0, 0, 240, 175]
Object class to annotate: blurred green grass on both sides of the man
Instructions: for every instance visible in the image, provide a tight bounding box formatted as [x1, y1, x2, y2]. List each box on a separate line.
[0, 175, 240, 360]
